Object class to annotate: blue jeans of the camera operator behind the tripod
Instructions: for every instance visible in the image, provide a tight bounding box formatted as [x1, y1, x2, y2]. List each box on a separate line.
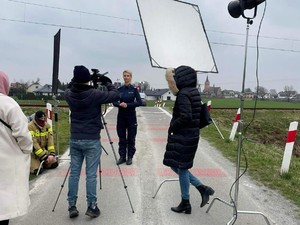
[68, 139, 102, 207]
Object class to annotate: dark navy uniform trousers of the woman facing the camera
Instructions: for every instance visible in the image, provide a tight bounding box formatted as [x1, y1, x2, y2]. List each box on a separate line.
[117, 110, 137, 159]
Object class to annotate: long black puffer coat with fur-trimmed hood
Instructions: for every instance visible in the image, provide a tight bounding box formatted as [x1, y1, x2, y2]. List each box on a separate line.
[163, 66, 201, 169]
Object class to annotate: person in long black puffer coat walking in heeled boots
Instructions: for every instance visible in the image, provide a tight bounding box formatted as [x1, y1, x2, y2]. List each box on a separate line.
[163, 66, 215, 214]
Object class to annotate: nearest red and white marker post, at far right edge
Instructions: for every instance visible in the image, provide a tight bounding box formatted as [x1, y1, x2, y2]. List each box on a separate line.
[280, 121, 298, 175]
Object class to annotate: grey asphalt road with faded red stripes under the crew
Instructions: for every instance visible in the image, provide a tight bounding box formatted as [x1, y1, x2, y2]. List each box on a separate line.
[10, 107, 300, 225]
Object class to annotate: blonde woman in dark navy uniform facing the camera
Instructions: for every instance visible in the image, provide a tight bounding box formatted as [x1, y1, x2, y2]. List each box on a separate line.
[113, 70, 142, 165]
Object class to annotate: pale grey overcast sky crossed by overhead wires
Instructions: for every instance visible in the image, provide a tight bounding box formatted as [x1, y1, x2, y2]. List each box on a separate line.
[0, 0, 300, 92]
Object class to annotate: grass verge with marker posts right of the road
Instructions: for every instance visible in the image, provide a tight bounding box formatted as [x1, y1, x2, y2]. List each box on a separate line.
[201, 109, 300, 213]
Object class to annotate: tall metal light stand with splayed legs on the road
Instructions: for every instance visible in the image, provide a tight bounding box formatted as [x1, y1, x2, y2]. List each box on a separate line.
[206, 16, 271, 225]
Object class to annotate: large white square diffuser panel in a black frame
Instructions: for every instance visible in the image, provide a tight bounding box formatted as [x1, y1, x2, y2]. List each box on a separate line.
[136, 0, 218, 73]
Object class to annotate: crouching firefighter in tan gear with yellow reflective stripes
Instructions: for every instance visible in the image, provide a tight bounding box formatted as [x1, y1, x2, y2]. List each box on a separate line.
[28, 111, 58, 174]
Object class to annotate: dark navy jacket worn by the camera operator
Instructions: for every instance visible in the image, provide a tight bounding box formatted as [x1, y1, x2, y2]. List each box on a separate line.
[65, 83, 120, 140]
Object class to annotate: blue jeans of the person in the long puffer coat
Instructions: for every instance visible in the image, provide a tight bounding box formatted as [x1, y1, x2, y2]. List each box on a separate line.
[171, 167, 202, 200]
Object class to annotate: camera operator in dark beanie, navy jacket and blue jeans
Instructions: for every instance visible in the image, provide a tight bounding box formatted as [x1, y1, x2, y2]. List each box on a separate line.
[65, 65, 120, 218]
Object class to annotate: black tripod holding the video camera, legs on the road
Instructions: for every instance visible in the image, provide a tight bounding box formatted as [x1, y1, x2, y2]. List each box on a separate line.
[52, 111, 134, 213]
